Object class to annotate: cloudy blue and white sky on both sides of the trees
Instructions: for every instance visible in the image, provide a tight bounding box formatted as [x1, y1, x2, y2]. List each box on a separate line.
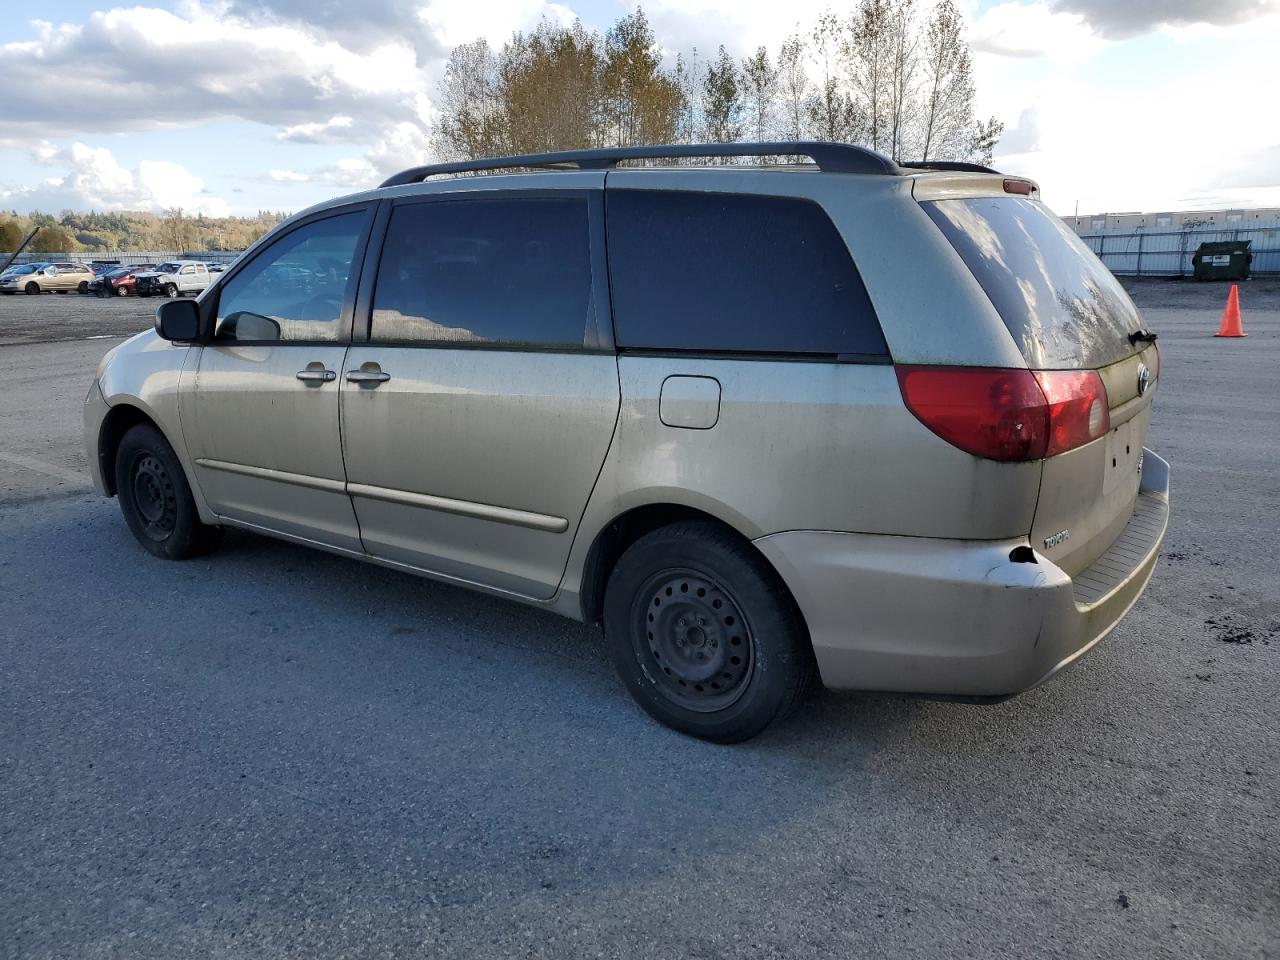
[0, 0, 1280, 214]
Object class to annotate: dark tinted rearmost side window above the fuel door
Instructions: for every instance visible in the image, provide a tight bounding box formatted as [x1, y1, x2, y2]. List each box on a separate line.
[607, 189, 888, 357]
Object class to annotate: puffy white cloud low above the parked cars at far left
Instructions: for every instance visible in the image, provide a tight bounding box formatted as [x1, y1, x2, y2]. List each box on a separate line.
[0, 142, 229, 216]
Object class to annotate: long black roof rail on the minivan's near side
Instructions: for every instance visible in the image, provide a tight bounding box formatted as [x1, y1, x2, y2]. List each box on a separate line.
[381, 140, 901, 187]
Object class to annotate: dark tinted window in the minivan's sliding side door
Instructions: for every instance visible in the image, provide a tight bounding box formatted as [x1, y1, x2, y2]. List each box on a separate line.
[370, 197, 591, 348]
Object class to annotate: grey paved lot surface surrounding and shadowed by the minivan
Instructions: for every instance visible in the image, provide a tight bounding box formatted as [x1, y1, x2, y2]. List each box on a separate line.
[0, 273, 1280, 960]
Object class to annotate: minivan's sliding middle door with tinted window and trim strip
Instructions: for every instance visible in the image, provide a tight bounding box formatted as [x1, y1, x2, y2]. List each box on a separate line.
[342, 185, 618, 598]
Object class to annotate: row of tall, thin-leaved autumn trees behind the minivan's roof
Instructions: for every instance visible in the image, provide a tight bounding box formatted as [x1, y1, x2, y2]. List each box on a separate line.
[431, 0, 1004, 163]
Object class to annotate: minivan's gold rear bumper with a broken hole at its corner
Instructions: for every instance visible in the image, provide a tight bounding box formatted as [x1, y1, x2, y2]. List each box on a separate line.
[755, 451, 1169, 696]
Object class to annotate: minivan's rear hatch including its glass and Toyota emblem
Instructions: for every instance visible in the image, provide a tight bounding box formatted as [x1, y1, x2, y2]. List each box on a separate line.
[916, 177, 1160, 576]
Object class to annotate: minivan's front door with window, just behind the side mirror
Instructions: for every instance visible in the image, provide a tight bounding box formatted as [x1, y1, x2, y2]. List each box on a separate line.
[182, 206, 370, 552]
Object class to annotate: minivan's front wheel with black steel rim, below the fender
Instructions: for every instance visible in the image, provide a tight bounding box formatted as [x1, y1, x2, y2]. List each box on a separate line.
[115, 424, 221, 561]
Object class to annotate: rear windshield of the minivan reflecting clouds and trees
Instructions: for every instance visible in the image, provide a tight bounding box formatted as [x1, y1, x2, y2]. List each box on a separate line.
[922, 197, 1142, 370]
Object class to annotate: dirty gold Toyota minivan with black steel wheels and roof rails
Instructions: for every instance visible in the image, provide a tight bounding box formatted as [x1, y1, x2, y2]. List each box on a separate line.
[84, 143, 1169, 742]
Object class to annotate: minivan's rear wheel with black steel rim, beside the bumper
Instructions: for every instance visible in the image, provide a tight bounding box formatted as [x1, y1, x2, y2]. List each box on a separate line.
[604, 521, 814, 744]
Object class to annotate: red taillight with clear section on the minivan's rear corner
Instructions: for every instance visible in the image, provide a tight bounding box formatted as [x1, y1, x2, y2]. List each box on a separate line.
[897, 366, 1111, 461]
